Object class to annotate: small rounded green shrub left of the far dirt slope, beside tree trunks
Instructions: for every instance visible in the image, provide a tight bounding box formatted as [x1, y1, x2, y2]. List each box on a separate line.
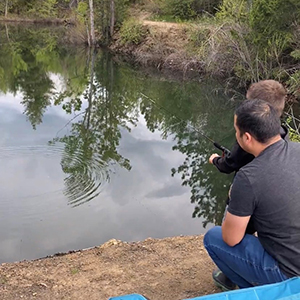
[120, 18, 147, 45]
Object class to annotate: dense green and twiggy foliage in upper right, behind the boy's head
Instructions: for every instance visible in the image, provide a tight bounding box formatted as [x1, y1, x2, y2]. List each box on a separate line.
[185, 0, 300, 97]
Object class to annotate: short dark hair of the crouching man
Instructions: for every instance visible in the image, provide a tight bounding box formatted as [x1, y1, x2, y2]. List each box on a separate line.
[235, 100, 281, 144]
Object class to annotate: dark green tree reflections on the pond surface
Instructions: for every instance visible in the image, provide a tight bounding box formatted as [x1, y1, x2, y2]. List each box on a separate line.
[0, 23, 234, 226]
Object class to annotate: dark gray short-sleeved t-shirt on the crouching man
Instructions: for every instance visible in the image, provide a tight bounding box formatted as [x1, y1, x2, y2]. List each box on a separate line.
[228, 140, 300, 277]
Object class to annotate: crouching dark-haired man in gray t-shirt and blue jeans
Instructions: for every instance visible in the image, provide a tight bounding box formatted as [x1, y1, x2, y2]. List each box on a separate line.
[204, 100, 300, 288]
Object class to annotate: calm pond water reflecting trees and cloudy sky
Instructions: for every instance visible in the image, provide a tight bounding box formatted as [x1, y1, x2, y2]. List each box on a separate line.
[0, 26, 234, 263]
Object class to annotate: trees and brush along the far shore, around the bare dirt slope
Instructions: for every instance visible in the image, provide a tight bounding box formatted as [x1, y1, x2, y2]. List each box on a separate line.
[0, 0, 300, 97]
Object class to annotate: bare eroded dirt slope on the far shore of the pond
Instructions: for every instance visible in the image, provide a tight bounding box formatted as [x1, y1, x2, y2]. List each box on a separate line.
[109, 13, 202, 77]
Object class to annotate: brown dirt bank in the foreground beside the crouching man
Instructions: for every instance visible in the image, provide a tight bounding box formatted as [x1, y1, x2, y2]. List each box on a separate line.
[0, 236, 219, 300]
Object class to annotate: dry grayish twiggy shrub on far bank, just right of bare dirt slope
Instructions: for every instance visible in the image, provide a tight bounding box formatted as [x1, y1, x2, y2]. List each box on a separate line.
[189, 23, 262, 81]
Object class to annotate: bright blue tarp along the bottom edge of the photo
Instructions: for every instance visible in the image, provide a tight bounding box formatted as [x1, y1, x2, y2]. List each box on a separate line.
[109, 277, 300, 300]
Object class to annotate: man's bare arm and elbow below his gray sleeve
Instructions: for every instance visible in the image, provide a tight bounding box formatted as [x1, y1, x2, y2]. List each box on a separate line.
[222, 212, 251, 247]
